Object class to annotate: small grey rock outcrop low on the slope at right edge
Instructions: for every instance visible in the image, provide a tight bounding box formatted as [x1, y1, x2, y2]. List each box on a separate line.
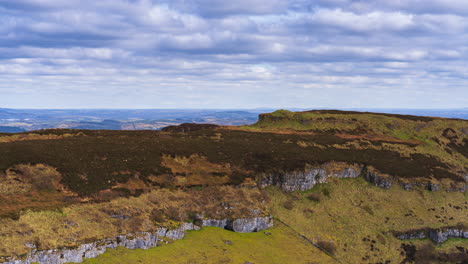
[395, 226, 468, 244]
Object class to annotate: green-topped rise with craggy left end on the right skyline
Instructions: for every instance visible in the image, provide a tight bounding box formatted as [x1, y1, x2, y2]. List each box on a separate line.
[250, 110, 468, 171]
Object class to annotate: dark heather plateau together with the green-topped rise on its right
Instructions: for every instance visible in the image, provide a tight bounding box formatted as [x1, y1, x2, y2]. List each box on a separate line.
[0, 111, 468, 200]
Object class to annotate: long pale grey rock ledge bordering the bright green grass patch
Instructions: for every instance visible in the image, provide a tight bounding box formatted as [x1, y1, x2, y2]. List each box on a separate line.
[0, 216, 273, 264]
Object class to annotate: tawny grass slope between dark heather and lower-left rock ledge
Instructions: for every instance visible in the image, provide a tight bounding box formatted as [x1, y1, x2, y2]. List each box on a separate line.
[0, 186, 269, 257]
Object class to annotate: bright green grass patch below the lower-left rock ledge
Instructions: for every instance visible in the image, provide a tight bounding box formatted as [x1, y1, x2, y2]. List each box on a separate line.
[75, 223, 335, 264]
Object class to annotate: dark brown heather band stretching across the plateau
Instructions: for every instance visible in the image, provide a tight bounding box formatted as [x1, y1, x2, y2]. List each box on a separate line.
[0, 124, 468, 195]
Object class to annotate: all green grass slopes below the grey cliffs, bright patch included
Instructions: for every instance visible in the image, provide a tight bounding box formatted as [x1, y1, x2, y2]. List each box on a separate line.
[71, 179, 468, 264]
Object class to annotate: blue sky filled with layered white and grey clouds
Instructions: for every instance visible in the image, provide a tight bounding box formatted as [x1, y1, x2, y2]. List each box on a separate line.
[0, 0, 468, 109]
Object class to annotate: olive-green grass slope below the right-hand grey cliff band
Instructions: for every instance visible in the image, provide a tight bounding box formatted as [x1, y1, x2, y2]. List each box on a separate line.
[268, 178, 468, 263]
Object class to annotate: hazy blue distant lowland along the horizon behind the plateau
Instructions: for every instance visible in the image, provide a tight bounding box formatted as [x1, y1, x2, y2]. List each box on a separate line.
[0, 108, 468, 131]
